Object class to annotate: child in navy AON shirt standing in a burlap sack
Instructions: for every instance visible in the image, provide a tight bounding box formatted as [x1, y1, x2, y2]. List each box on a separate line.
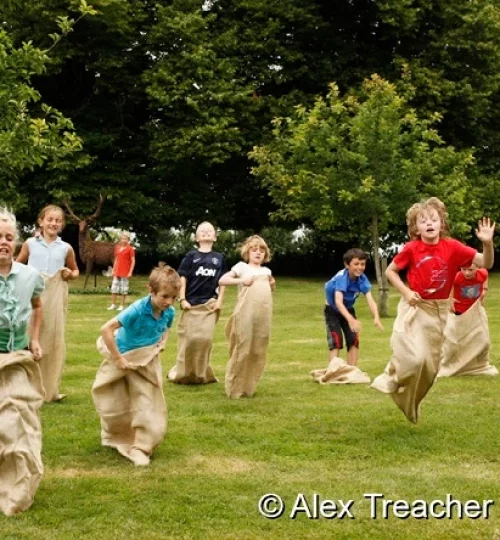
[168, 221, 225, 384]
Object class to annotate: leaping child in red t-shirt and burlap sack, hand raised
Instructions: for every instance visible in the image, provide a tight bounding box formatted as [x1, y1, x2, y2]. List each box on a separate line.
[372, 197, 495, 423]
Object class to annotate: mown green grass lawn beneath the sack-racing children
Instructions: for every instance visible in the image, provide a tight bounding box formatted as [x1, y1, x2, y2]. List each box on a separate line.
[0, 275, 500, 540]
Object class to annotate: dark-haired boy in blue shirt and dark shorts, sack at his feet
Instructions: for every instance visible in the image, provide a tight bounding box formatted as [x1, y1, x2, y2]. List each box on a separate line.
[325, 248, 384, 366]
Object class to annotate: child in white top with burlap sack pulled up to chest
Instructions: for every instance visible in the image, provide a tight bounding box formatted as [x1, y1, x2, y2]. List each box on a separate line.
[219, 235, 276, 398]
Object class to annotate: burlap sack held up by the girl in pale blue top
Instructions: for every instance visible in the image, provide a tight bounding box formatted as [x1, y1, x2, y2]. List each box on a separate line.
[39, 270, 68, 401]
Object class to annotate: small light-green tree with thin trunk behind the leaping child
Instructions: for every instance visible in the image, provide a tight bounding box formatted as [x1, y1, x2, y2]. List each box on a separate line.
[250, 75, 473, 315]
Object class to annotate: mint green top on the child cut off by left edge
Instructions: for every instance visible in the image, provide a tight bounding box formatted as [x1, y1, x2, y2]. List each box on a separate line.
[0, 262, 44, 352]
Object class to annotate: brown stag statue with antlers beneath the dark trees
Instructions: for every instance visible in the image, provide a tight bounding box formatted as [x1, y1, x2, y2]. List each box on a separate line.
[64, 195, 115, 289]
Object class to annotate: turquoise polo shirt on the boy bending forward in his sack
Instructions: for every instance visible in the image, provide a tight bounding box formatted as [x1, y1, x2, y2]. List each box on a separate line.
[116, 295, 175, 354]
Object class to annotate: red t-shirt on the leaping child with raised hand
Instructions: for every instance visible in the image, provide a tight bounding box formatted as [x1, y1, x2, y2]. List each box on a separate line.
[393, 238, 477, 300]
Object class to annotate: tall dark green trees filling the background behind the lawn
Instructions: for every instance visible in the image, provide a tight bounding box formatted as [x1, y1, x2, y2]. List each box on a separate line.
[0, 0, 500, 240]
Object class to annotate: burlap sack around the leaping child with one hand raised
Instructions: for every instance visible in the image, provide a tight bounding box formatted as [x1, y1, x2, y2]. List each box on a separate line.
[371, 298, 449, 423]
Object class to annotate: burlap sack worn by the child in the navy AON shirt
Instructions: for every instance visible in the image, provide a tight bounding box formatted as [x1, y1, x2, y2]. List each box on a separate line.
[168, 298, 220, 384]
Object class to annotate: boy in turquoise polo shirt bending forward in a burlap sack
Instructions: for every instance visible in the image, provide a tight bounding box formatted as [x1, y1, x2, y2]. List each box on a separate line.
[92, 264, 180, 466]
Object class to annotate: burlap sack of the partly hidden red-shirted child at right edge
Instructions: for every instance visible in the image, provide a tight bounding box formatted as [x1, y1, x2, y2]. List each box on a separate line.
[438, 302, 498, 377]
